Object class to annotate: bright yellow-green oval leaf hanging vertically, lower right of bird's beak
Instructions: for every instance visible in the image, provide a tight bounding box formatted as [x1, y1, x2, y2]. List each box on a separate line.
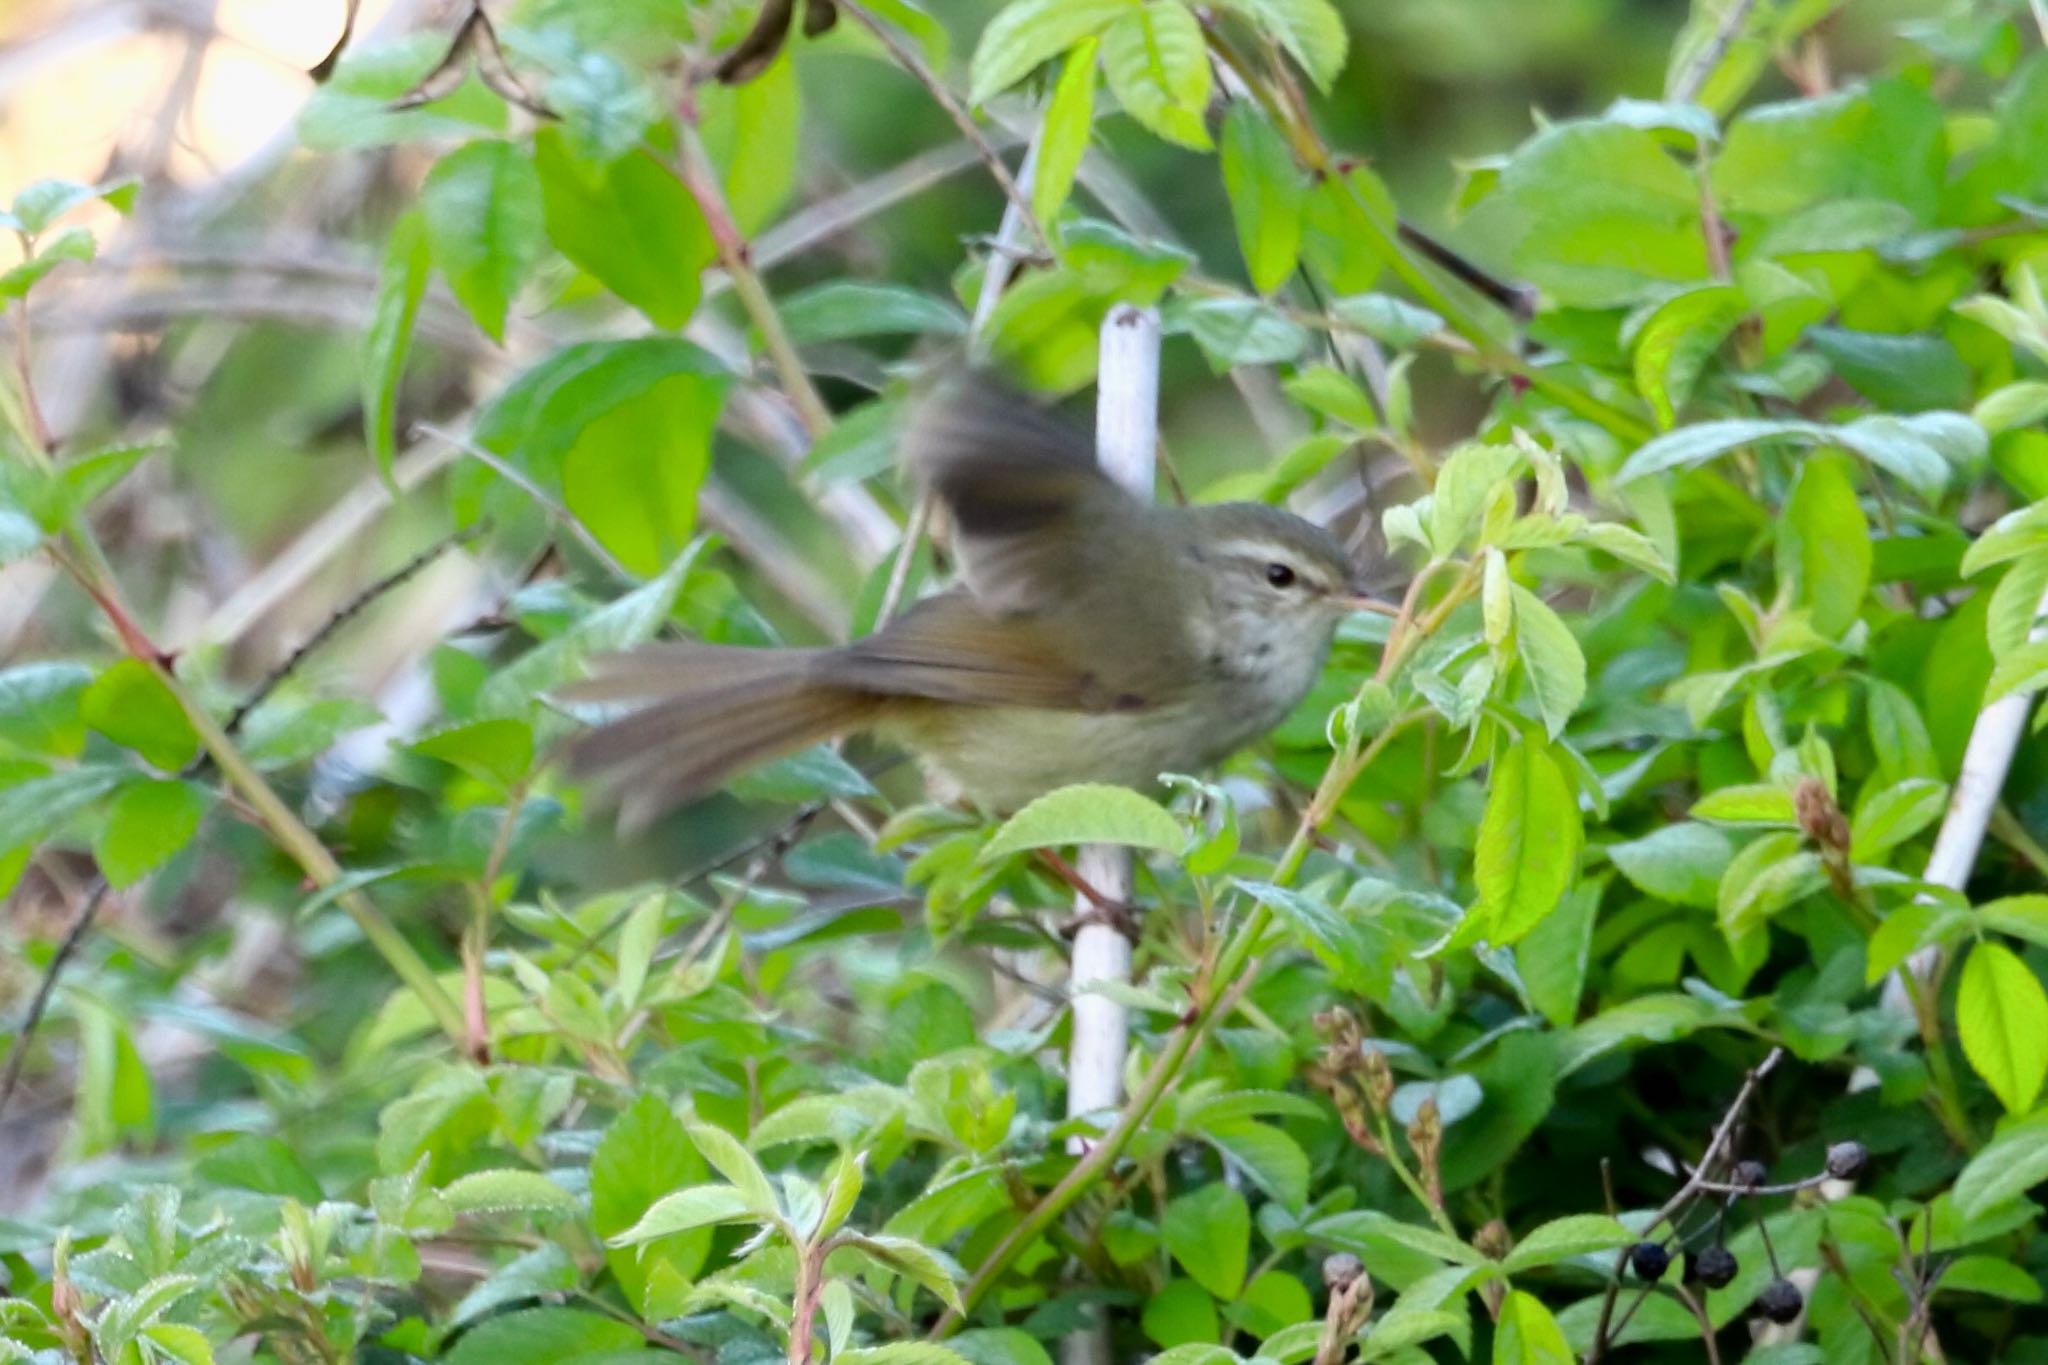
[1460, 739, 1581, 948]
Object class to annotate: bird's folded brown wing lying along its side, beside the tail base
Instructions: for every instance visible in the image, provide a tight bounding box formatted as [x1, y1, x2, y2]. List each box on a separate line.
[815, 589, 1151, 710]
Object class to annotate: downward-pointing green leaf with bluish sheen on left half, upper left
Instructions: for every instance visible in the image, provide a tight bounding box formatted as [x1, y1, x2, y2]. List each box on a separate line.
[420, 141, 545, 342]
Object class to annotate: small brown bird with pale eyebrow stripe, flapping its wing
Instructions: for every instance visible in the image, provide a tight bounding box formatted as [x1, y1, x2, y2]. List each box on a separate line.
[565, 375, 1386, 827]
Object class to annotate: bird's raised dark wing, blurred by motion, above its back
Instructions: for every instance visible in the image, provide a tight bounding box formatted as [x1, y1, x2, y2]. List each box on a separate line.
[903, 372, 1130, 616]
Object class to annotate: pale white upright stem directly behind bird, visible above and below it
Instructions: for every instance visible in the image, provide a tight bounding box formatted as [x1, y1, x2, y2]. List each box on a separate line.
[1059, 305, 1159, 1365]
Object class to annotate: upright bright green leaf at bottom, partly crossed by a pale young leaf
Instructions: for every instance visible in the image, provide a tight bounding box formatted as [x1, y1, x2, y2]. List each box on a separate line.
[590, 1095, 711, 1310]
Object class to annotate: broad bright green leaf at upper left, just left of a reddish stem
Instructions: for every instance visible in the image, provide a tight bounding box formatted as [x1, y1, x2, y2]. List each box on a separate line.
[532, 127, 719, 329]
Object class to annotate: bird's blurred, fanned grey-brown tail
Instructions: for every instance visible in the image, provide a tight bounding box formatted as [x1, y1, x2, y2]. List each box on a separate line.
[563, 645, 879, 829]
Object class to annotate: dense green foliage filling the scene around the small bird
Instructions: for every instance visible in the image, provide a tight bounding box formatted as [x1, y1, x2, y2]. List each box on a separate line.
[0, 0, 2048, 1365]
